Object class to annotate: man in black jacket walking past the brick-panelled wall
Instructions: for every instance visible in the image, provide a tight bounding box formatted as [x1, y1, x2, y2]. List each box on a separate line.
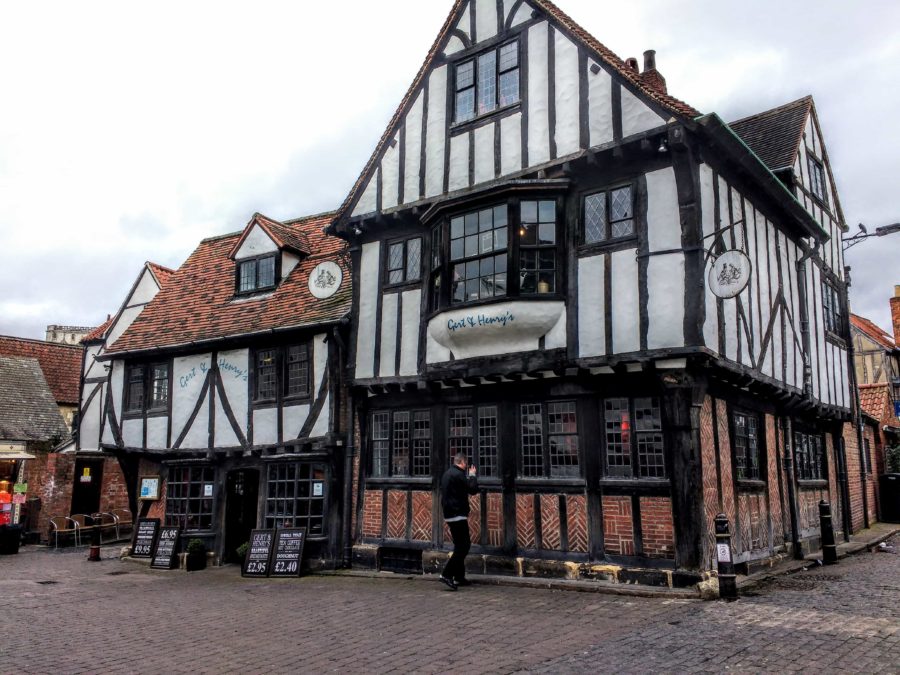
[441, 452, 478, 591]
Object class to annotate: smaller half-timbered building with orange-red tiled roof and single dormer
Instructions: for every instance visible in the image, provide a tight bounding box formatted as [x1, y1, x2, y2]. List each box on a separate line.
[90, 214, 351, 567]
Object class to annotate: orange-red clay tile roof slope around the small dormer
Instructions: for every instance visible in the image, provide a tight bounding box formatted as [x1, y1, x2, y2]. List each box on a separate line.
[107, 213, 352, 354]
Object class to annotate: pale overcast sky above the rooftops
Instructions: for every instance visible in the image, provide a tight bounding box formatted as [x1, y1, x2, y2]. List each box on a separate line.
[0, 0, 900, 338]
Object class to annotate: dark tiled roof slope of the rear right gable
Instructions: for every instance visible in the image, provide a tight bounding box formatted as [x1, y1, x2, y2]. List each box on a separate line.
[728, 96, 812, 171]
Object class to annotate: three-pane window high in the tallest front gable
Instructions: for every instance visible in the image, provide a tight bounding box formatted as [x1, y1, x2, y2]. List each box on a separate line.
[454, 41, 519, 123]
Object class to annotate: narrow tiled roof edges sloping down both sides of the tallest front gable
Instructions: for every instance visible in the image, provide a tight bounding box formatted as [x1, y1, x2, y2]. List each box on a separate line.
[335, 0, 700, 227]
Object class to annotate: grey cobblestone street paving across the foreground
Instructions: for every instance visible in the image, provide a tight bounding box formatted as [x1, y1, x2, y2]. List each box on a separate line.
[0, 536, 900, 673]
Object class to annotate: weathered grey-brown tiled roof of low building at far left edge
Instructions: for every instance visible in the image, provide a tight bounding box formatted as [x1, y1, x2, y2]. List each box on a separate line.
[0, 356, 68, 441]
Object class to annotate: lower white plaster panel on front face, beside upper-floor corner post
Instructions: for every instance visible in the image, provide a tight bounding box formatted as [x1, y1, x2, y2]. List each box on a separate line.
[647, 253, 684, 349]
